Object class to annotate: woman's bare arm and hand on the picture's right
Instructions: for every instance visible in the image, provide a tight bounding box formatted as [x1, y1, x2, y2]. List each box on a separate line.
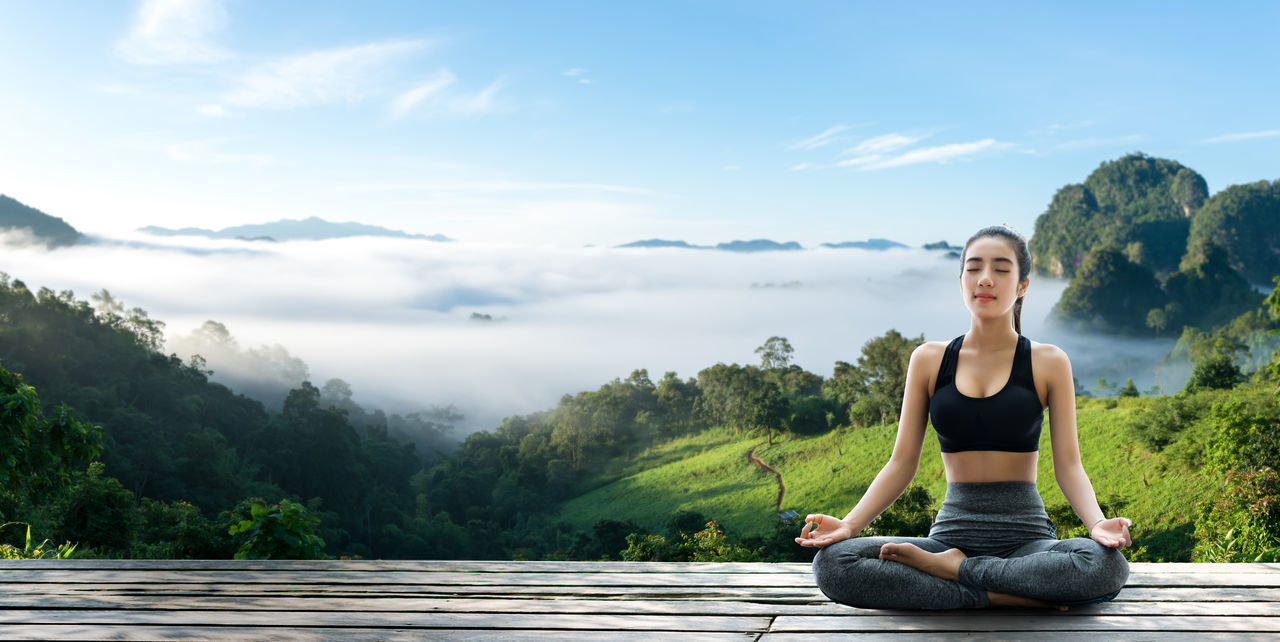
[1044, 347, 1132, 546]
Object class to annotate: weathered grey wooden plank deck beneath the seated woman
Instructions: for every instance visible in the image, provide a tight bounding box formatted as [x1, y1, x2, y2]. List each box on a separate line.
[0, 560, 1280, 642]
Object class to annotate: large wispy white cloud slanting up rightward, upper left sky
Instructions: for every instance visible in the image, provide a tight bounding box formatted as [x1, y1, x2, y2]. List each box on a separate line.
[224, 40, 426, 109]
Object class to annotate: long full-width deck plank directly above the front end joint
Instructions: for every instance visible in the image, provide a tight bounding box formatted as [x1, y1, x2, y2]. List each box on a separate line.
[0, 595, 1280, 616]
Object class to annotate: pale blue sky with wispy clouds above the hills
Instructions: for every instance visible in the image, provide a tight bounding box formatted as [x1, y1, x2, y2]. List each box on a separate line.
[0, 0, 1280, 246]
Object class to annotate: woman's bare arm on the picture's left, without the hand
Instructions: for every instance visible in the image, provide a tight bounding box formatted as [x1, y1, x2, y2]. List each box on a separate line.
[842, 344, 931, 535]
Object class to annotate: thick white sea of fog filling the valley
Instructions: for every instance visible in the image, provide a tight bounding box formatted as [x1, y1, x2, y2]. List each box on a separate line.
[0, 234, 1187, 439]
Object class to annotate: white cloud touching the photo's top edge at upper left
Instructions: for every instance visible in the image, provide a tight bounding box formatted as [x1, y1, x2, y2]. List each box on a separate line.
[116, 0, 230, 64]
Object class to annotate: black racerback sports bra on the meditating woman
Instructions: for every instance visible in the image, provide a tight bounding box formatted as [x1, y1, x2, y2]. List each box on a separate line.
[929, 335, 1044, 453]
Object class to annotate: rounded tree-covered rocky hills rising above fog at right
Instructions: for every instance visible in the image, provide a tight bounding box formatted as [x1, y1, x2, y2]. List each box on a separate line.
[1029, 153, 1280, 338]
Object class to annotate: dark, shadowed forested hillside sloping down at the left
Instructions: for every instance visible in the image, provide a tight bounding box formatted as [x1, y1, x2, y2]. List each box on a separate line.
[0, 272, 454, 556]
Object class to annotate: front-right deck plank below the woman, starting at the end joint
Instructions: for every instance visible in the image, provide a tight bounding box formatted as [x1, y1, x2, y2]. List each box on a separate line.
[769, 611, 1280, 633]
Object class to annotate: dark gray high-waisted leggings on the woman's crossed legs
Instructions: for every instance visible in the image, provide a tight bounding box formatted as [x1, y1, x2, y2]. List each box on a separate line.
[813, 482, 1129, 609]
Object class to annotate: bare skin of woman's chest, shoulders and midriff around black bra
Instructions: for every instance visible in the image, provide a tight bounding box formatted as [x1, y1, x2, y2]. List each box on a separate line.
[922, 341, 1048, 482]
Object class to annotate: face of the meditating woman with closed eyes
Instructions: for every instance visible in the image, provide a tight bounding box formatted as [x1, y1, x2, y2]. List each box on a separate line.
[960, 237, 1030, 318]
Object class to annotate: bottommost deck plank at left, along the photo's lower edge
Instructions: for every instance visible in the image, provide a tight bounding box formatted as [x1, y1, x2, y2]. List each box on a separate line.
[0, 624, 758, 642]
